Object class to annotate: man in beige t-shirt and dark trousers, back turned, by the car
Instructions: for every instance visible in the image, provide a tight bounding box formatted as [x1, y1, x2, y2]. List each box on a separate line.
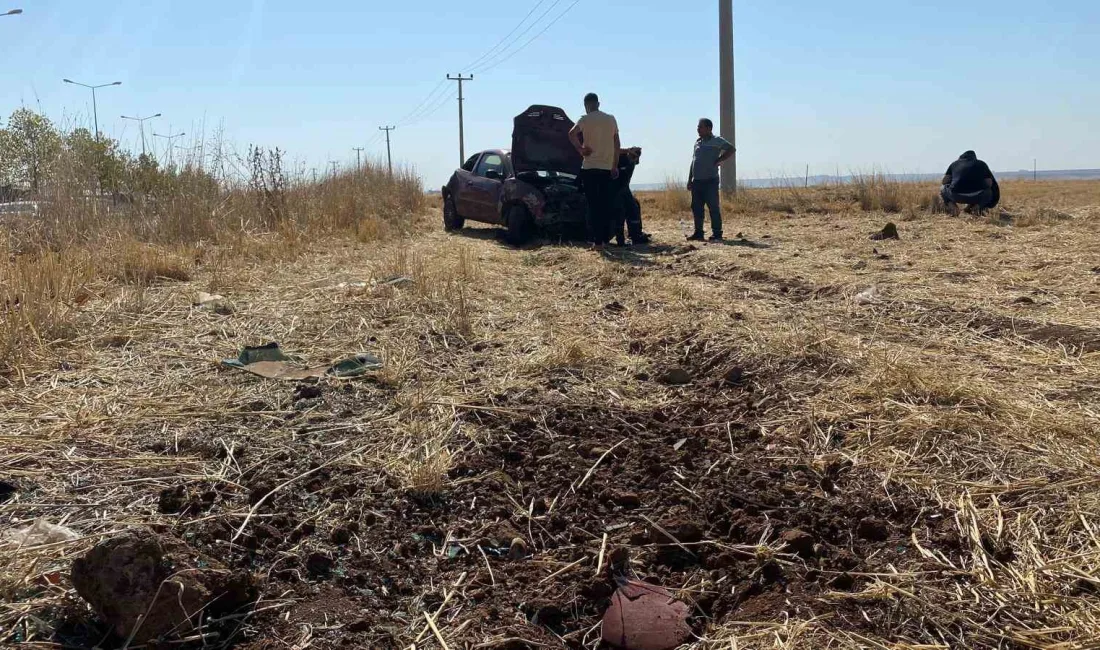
[569, 92, 622, 249]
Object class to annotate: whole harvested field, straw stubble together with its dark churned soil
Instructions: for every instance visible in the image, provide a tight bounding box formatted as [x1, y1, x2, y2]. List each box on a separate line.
[0, 183, 1100, 650]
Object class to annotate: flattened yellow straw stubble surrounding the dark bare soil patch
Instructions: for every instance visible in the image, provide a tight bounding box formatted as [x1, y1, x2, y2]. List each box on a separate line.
[0, 180, 1100, 650]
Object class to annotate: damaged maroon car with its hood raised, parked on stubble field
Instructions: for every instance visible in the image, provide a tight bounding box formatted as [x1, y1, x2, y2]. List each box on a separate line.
[442, 106, 587, 244]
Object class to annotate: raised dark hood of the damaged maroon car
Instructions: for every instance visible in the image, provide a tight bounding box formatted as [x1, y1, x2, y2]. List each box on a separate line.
[512, 106, 583, 175]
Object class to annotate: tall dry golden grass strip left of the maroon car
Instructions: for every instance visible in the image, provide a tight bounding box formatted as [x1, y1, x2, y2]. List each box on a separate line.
[0, 158, 425, 371]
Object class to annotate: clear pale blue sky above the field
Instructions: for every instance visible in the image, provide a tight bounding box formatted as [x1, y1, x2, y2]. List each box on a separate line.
[0, 0, 1100, 187]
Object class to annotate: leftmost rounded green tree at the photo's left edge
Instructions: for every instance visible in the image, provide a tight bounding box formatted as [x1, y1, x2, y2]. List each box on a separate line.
[0, 108, 62, 191]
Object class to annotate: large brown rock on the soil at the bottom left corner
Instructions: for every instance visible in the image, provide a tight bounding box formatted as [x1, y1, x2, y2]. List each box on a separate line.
[73, 531, 256, 645]
